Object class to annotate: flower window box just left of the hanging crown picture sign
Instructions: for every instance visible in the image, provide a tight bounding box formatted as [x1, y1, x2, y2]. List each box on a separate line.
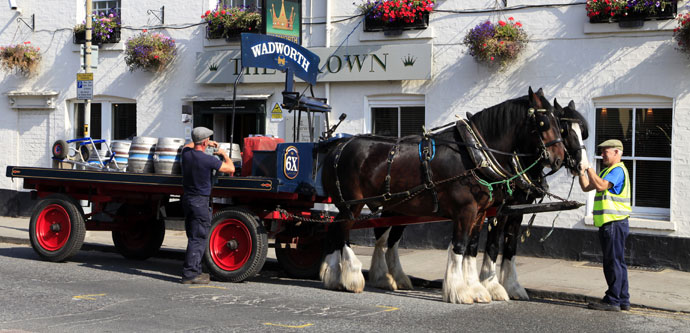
[201, 6, 261, 42]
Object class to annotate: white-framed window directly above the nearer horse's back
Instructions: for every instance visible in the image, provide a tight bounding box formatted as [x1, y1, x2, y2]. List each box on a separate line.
[369, 96, 425, 137]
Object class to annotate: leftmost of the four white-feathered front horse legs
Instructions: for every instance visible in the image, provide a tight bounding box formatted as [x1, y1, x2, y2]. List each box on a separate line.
[442, 209, 476, 304]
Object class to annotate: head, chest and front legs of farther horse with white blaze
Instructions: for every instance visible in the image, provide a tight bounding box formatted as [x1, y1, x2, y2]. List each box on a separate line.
[479, 99, 589, 300]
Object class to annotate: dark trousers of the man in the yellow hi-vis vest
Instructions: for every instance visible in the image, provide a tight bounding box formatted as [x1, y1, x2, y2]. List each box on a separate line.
[599, 218, 630, 305]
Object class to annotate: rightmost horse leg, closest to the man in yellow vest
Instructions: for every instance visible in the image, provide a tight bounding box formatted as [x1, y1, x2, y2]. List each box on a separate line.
[500, 215, 529, 300]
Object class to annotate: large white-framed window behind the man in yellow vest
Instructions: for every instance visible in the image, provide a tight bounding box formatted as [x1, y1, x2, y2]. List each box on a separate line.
[595, 96, 673, 217]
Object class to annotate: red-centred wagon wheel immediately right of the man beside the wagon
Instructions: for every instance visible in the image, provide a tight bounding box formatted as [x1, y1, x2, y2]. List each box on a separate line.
[204, 208, 268, 282]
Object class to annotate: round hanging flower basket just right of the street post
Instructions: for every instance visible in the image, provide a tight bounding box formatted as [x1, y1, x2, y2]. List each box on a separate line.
[125, 30, 177, 72]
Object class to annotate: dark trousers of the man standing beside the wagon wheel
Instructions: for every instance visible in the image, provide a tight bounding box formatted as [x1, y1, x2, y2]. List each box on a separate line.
[182, 195, 211, 279]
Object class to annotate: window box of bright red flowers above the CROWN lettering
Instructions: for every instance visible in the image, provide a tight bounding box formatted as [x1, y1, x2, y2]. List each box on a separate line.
[358, 0, 435, 32]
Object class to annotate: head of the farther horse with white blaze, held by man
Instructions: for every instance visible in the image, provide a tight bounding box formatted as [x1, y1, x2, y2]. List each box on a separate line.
[553, 98, 589, 175]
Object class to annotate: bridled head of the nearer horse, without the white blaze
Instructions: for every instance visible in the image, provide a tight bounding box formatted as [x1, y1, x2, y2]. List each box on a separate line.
[527, 87, 566, 171]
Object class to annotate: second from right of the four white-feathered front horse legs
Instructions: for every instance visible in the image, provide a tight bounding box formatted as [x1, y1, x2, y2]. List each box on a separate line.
[479, 217, 510, 301]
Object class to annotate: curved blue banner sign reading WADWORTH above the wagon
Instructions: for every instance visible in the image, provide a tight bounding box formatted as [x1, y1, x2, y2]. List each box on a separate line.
[242, 33, 320, 85]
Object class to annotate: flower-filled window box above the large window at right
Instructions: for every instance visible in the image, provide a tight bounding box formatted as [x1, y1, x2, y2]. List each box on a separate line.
[585, 0, 678, 28]
